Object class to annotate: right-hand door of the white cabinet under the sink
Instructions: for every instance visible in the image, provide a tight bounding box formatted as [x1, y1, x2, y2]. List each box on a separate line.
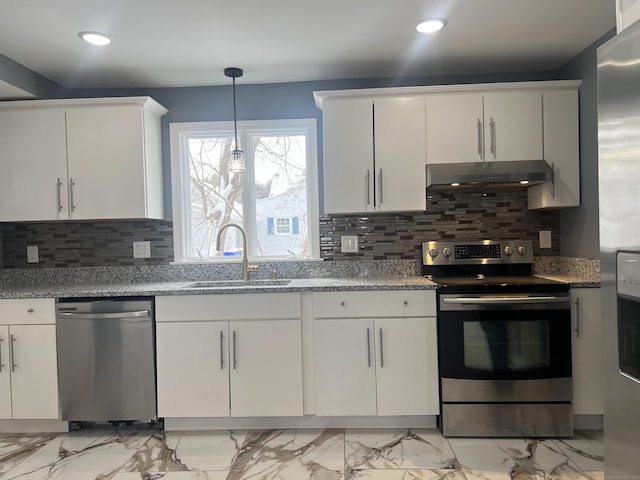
[229, 320, 302, 417]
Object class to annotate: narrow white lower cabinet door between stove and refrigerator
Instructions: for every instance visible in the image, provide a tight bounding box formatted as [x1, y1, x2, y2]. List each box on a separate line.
[571, 288, 604, 415]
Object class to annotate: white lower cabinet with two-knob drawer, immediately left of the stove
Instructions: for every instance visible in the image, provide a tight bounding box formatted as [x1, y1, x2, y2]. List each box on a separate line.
[313, 291, 439, 416]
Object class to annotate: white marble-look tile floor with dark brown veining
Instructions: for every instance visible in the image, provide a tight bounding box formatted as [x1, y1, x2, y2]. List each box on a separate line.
[0, 429, 604, 480]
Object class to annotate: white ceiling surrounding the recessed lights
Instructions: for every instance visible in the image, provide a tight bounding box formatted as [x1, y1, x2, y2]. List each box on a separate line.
[0, 0, 615, 93]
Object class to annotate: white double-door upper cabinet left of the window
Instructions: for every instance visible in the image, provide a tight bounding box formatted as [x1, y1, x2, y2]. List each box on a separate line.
[0, 97, 166, 221]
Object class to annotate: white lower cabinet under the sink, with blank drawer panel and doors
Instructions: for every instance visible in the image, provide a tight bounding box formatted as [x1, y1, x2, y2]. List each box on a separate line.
[156, 294, 303, 417]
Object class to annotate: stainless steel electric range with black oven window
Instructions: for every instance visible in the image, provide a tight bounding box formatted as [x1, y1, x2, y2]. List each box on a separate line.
[422, 240, 573, 437]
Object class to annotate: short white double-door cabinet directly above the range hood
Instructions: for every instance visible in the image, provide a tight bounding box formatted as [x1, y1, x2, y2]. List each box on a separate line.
[427, 92, 543, 163]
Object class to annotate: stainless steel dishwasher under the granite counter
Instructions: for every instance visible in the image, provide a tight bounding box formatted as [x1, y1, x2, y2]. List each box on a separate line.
[56, 297, 157, 423]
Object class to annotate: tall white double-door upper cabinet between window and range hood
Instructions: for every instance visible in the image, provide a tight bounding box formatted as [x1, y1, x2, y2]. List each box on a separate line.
[322, 96, 426, 213]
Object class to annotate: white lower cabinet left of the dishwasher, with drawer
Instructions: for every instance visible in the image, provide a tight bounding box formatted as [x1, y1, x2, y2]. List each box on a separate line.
[0, 299, 59, 420]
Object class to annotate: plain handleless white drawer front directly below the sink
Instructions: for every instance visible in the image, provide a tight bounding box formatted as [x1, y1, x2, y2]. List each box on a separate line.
[156, 293, 301, 322]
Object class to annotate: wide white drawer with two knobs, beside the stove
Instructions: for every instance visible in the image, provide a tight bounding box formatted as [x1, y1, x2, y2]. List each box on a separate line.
[313, 290, 436, 318]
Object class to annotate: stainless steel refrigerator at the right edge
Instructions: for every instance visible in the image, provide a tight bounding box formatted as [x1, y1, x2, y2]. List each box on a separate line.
[598, 17, 640, 479]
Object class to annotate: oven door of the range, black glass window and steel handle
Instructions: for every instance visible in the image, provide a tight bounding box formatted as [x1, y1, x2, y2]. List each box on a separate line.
[438, 293, 572, 401]
